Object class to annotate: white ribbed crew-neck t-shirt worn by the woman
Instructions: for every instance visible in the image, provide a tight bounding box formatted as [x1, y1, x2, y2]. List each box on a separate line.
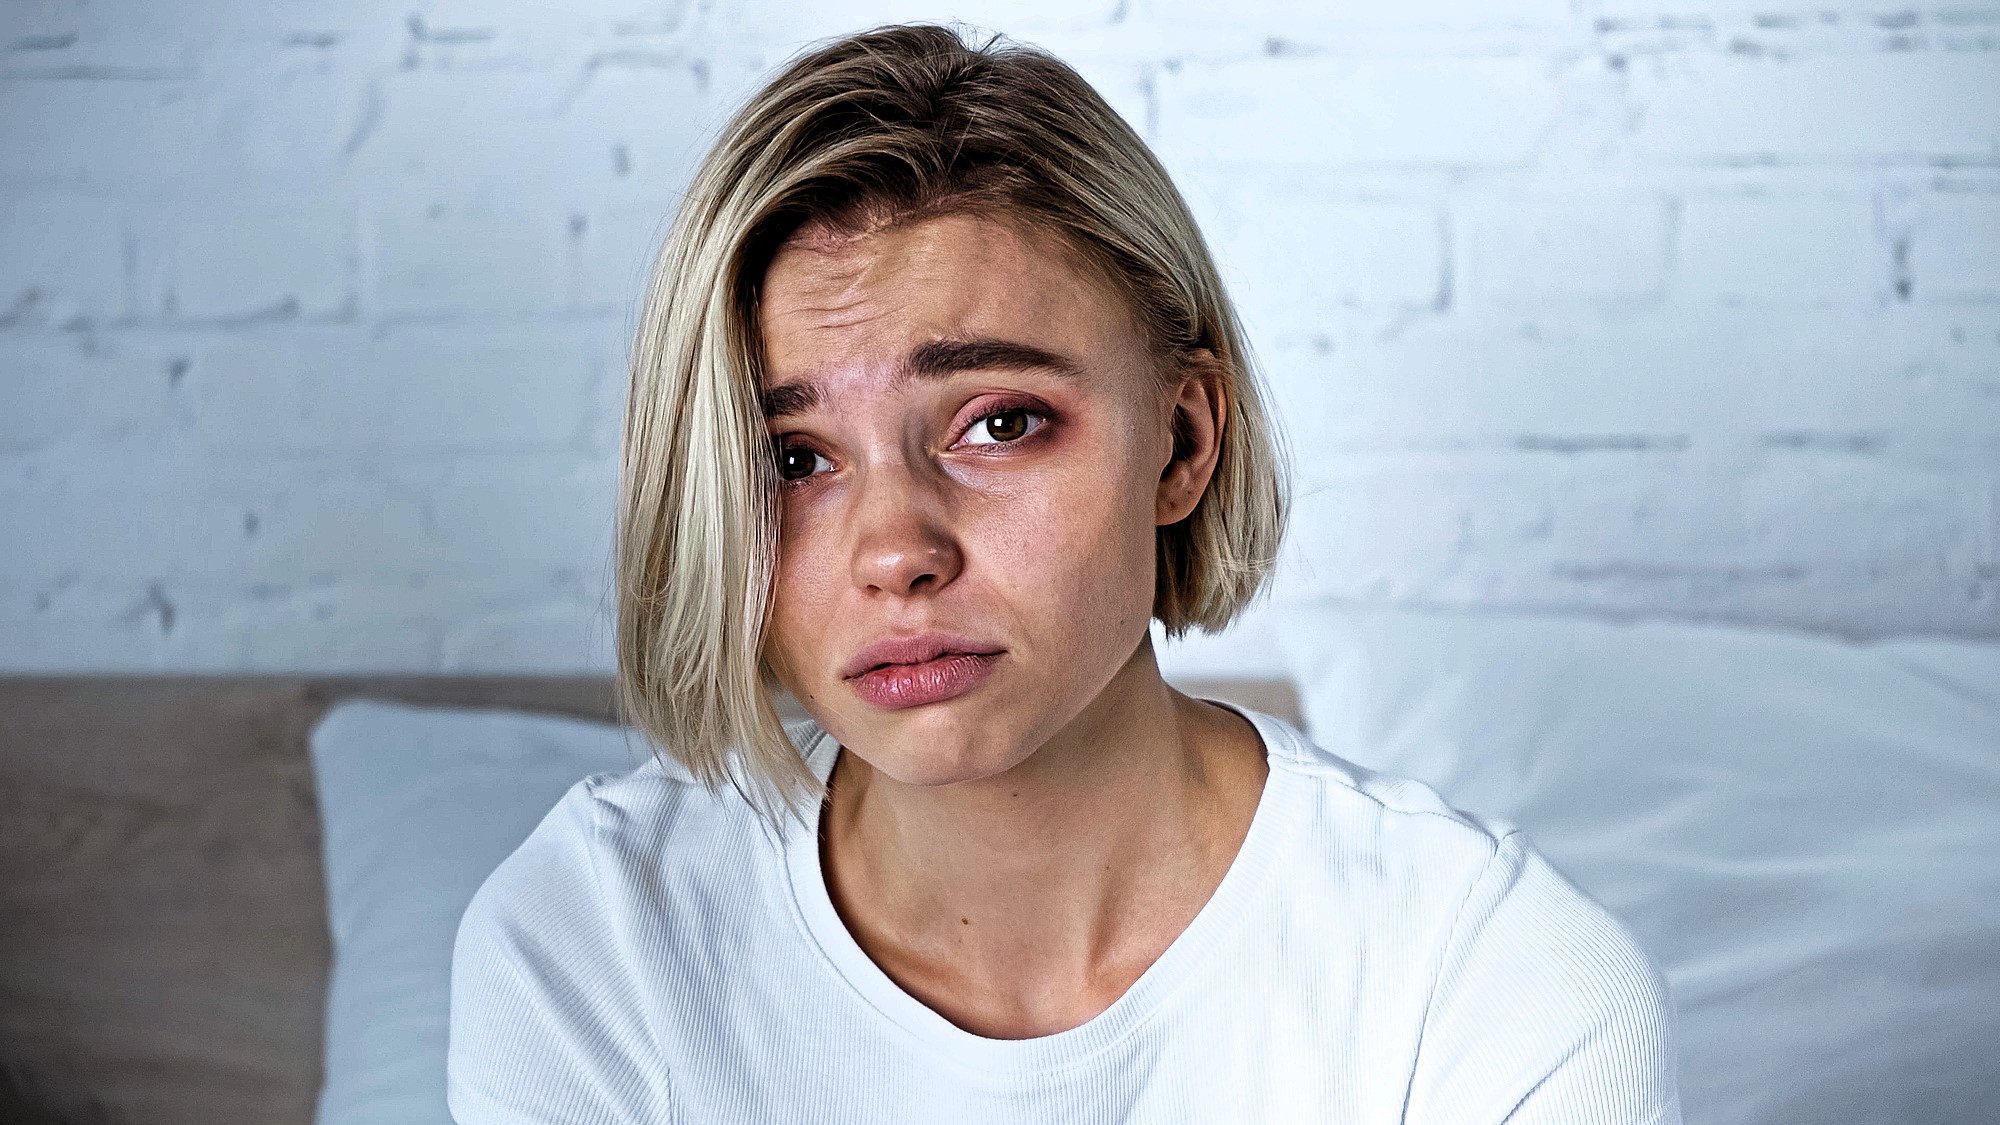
[450, 711, 1680, 1125]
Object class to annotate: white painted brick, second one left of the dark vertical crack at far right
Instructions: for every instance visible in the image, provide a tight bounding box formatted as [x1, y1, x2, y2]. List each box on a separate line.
[1452, 196, 1670, 304]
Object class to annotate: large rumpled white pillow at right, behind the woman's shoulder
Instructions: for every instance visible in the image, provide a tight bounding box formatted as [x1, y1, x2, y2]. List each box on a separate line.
[1282, 605, 2000, 1125]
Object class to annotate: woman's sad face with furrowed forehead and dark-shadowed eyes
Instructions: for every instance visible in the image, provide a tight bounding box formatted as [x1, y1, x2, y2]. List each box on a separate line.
[758, 216, 1206, 785]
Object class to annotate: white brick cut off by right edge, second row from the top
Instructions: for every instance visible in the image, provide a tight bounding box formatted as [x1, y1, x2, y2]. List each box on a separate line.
[1632, 52, 2000, 160]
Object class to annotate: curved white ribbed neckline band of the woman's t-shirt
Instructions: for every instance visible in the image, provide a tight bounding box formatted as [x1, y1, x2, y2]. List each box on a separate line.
[782, 701, 1310, 1075]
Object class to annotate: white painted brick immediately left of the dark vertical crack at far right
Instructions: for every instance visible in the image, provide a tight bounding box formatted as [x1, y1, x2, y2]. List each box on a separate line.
[1672, 196, 1890, 304]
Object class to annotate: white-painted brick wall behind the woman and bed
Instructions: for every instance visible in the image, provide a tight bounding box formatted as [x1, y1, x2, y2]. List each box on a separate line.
[0, 0, 2000, 675]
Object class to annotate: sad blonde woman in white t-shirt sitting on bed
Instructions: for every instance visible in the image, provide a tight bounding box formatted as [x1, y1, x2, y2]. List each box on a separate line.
[450, 26, 1680, 1125]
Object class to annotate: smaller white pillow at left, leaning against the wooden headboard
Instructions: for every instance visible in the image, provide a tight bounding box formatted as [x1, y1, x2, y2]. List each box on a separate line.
[312, 701, 646, 1125]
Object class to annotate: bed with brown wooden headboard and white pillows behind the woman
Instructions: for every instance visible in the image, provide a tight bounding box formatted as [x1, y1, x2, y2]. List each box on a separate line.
[0, 603, 2000, 1125]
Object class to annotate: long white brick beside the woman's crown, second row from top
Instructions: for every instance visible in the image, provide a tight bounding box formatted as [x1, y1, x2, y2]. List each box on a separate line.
[1158, 58, 1556, 168]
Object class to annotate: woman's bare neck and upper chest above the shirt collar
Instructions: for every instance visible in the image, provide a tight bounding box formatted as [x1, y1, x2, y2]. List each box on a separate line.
[820, 645, 1268, 1039]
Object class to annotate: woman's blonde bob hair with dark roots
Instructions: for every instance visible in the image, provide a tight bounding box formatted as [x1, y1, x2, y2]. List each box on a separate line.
[616, 24, 1286, 817]
